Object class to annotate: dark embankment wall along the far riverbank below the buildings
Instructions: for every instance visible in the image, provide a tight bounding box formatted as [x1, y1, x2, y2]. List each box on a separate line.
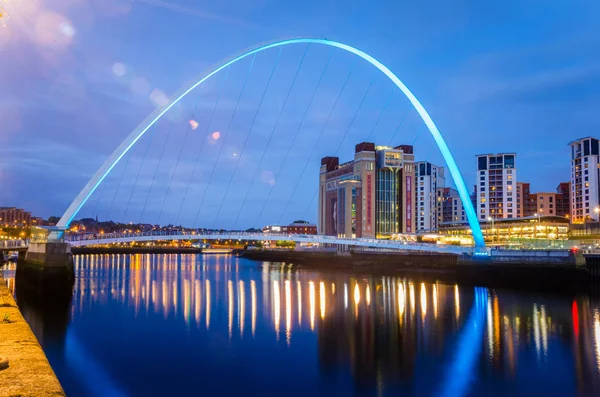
[241, 250, 591, 291]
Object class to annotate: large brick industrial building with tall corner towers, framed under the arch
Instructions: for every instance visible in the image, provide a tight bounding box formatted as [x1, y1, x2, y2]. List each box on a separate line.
[317, 142, 416, 237]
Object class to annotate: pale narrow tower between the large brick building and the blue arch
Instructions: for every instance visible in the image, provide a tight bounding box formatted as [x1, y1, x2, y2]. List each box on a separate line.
[415, 161, 445, 230]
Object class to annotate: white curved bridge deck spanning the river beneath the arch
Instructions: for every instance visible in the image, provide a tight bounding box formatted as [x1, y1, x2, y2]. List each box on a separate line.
[65, 232, 477, 255]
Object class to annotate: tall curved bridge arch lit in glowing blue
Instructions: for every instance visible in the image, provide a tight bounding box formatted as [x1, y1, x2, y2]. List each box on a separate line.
[57, 38, 485, 248]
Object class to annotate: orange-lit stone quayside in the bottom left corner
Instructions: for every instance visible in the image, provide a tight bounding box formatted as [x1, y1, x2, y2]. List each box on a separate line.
[0, 270, 65, 397]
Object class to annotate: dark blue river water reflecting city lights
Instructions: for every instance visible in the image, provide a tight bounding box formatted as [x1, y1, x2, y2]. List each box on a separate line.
[5, 255, 600, 397]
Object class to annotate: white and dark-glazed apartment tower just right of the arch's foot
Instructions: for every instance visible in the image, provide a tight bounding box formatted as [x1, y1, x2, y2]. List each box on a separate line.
[475, 153, 518, 221]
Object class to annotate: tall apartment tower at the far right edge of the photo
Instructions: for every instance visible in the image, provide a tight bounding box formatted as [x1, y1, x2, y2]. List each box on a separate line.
[569, 137, 600, 223]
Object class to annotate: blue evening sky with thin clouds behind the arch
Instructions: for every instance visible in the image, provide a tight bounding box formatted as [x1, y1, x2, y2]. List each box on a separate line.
[0, 0, 600, 228]
